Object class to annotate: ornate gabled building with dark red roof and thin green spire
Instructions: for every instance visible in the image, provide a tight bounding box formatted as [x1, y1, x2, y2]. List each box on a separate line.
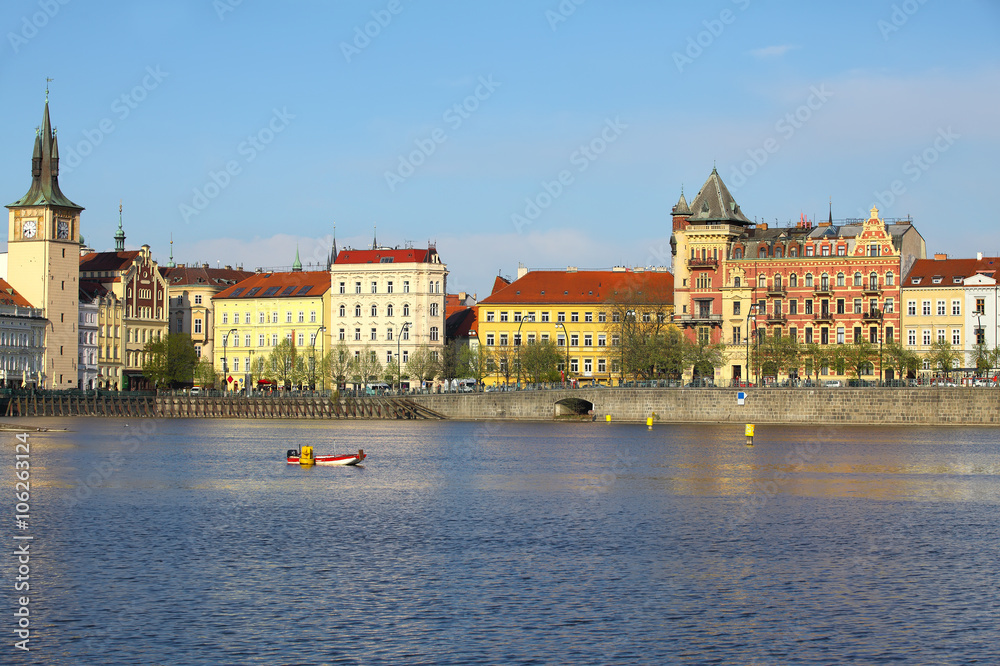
[79, 217, 168, 390]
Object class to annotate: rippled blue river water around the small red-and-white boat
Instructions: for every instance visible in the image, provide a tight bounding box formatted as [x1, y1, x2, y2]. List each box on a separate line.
[0, 419, 1000, 665]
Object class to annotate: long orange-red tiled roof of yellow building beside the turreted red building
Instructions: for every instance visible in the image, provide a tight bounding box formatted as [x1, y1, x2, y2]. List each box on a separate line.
[480, 271, 674, 305]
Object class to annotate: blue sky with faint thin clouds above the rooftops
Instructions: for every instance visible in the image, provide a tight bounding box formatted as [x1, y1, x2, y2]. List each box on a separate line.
[0, 0, 1000, 298]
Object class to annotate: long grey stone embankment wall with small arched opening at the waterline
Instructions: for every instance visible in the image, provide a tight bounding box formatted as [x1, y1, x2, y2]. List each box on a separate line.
[413, 387, 1000, 425]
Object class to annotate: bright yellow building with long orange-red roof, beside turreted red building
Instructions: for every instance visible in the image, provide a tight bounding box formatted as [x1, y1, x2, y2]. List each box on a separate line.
[477, 266, 674, 385]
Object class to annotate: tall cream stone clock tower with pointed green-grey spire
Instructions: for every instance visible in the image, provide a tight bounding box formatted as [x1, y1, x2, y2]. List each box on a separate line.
[7, 95, 83, 389]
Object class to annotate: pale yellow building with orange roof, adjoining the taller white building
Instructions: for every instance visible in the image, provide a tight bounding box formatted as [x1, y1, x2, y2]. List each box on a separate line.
[208, 271, 330, 391]
